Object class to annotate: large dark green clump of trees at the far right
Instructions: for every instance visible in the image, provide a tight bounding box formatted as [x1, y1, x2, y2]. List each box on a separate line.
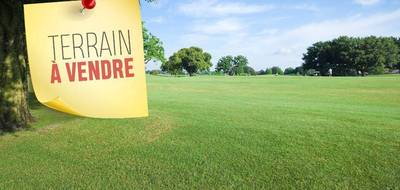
[303, 36, 400, 76]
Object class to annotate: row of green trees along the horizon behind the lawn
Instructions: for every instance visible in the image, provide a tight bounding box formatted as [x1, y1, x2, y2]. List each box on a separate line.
[157, 36, 400, 76]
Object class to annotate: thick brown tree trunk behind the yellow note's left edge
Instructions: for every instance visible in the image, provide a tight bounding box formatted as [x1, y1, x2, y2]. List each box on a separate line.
[0, 0, 32, 131]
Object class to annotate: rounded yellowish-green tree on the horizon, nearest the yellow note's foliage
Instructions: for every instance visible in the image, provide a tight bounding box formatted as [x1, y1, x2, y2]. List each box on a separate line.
[161, 47, 212, 76]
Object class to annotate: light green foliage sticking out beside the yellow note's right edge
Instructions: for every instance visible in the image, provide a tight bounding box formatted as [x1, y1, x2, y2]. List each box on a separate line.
[143, 23, 167, 64]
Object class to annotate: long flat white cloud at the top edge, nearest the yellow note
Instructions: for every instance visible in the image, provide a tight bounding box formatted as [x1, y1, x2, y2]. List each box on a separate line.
[178, 0, 274, 17]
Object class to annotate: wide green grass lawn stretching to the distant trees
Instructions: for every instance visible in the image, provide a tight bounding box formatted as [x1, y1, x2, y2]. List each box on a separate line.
[0, 75, 400, 189]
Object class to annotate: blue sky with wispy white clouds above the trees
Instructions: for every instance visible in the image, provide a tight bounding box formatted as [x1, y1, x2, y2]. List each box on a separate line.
[142, 0, 400, 70]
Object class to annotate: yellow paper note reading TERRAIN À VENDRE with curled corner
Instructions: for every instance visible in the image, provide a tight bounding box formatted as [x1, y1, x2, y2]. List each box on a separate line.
[24, 0, 148, 118]
